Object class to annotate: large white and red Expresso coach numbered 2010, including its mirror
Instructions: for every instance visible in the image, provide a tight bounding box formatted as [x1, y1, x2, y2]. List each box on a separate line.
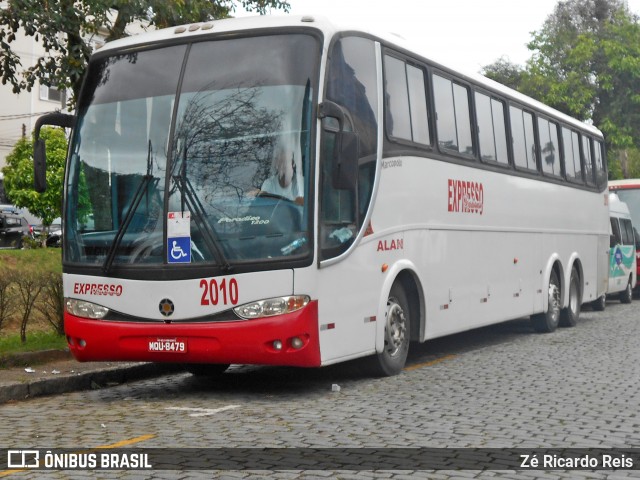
[35, 16, 609, 375]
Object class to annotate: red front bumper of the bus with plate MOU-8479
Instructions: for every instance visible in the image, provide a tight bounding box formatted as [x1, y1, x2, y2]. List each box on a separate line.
[65, 301, 321, 367]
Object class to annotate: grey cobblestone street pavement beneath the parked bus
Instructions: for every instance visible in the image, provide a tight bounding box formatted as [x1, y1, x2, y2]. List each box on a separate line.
[0, 301, 640, 480]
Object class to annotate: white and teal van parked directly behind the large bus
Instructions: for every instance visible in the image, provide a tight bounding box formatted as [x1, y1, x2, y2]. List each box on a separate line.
[594, 193, 637, 310]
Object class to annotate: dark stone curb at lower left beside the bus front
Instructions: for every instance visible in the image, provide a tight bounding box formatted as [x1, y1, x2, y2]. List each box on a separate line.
[0, 363, 183, 404]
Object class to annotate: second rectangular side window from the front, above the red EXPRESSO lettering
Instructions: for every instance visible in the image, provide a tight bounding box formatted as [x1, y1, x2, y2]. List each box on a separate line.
[433, 75, 473, 155]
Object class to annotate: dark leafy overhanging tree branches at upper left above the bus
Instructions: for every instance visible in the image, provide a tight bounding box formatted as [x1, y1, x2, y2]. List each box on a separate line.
[0, 0, 289, 104]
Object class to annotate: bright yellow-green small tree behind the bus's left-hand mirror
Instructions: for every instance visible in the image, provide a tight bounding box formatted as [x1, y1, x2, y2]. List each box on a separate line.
[2, 127, 67, 225]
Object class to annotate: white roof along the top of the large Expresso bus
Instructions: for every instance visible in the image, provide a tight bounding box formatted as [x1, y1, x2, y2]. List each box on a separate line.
[98, 15, 603, 138]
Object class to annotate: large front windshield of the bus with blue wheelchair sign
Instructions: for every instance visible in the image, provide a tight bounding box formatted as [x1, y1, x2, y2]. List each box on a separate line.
[64, 34, 320, 271]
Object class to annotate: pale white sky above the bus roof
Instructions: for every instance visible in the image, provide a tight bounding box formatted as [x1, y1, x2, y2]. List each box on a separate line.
[240, 0, 640, 72]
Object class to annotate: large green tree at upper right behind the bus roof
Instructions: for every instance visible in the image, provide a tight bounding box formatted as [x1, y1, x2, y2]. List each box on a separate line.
[484, 0, 640, 154]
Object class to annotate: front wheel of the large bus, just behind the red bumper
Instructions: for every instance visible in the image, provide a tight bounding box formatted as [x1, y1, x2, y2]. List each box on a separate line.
[365, 283, 411, 377]
